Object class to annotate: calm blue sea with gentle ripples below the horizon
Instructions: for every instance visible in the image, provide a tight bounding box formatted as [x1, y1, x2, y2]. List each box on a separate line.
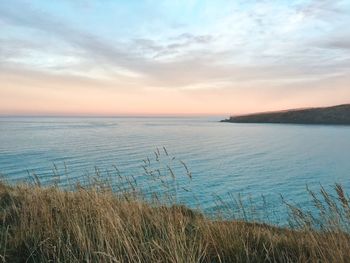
[0, 117, 350, 223]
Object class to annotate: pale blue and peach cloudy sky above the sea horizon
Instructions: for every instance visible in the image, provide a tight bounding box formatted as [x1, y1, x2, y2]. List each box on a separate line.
[0, 0, 350, 115]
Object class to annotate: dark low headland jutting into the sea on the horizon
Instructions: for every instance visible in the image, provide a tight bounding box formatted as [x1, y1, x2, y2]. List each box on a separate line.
[222, 104, 350, 125]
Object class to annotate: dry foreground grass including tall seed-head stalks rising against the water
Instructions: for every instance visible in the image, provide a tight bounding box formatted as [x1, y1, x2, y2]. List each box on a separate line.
[0, 149, 350, 263]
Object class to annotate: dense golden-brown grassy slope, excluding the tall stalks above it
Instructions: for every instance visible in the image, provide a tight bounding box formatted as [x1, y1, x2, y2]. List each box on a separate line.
[0, 184, 350, 262]
